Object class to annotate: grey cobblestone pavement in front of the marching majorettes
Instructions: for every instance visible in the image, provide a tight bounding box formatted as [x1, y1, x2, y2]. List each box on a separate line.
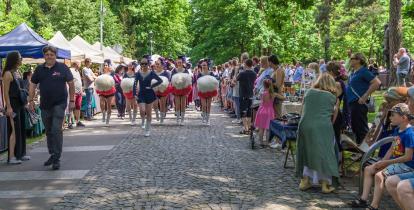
[54, 106, 396, 209]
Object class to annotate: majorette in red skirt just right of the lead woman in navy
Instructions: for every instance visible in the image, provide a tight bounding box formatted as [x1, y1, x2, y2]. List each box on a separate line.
[154, 58, 171, 123]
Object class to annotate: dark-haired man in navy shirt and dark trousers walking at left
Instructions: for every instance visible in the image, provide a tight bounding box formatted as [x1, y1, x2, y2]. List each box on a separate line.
[29, 46, 75, 170]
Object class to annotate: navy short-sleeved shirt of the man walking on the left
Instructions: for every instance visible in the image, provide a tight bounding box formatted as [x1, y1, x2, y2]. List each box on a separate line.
[31, 62, 73, 109]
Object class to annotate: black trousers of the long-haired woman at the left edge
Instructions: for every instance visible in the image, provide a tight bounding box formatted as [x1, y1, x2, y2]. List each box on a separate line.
[7, 107, 26, 160]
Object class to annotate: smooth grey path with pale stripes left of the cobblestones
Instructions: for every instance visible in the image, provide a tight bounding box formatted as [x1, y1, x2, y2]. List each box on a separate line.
[0, 113, 132, 209]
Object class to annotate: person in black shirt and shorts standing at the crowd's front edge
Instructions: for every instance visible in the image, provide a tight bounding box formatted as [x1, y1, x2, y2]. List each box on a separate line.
[237, 59, 256, 134]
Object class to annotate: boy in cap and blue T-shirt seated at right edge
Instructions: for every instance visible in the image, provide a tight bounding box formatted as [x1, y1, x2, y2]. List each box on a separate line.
[351, 103, 414, 210]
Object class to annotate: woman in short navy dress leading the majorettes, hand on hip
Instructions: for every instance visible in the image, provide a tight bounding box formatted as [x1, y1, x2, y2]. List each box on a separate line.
[133, 58, 162, 137]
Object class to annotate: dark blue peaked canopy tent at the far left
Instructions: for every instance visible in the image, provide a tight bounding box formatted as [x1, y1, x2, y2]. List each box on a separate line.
[0, 23, 71, 59]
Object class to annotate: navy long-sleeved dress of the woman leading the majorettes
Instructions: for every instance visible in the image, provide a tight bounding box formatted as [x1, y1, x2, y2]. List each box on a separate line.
[133, 71, 162, 104]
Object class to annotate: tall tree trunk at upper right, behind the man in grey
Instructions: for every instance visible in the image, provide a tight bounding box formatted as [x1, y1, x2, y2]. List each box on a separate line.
[389, 0, 402, 84]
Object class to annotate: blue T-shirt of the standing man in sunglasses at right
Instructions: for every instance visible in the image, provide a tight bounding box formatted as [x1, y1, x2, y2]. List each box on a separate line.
[345, 66, 375, 103]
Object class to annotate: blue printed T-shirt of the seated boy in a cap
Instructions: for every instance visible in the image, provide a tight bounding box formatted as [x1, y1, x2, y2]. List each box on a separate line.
[391, 127, 414, 168]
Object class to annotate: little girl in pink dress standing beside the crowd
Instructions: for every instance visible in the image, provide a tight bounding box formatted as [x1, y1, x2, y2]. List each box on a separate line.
[254, 79, 275, 147]
